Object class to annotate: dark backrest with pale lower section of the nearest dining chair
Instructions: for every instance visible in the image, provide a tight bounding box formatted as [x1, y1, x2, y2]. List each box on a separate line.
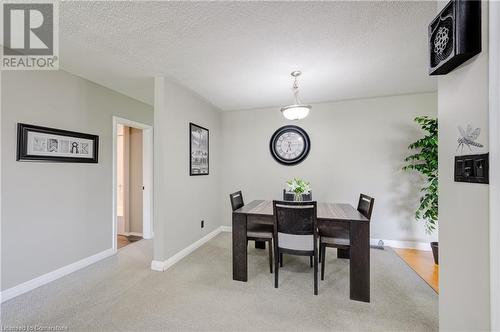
[273, 201, 318, 251]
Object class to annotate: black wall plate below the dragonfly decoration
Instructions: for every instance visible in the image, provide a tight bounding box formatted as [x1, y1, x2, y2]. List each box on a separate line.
[455, 153, 489, 183]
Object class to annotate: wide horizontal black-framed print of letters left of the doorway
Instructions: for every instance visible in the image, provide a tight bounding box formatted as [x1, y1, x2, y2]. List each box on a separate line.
[17, 123, 99, 163]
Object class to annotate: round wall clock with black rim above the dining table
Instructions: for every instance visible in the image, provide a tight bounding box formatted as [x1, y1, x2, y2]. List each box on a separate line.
[269, 126, 311, 165]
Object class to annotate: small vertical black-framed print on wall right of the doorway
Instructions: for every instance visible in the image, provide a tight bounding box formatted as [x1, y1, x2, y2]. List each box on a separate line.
[189, 123, 209, 175]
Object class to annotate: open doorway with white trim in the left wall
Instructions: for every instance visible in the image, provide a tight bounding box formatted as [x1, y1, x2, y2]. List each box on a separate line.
[112, 117, 153, 252]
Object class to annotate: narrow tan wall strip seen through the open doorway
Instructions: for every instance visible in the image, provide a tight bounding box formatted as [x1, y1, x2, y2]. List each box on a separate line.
[129, 128, 143, 233]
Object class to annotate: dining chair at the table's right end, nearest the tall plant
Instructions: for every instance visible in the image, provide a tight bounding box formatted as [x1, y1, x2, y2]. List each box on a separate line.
[319, 194, 375, 280]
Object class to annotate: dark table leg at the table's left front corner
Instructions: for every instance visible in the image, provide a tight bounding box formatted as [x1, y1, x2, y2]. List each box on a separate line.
[233, 213, 248, 281]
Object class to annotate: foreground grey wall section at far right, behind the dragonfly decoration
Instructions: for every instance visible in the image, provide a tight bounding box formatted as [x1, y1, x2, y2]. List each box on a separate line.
[438, 2, 490, 331]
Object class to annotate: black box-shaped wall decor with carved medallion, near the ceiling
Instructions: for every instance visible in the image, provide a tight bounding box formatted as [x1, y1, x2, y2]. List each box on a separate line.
[429, 0, 481, 75]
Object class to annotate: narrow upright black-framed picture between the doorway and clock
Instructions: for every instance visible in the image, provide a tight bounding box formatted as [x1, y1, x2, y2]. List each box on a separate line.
[189, 122, 210, 176]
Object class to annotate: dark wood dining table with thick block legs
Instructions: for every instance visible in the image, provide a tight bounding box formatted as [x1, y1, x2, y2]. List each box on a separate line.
[233, 200, 370, 302]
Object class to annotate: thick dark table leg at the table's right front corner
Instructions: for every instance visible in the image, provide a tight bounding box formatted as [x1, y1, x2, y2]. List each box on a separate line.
[349, 222, 370, 302]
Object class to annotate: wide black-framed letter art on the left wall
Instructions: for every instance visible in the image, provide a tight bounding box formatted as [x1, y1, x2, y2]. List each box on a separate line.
[16, 123, 99, 164]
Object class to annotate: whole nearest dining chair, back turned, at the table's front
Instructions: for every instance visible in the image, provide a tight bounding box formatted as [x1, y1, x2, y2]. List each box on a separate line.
[273, 201, 318, 295]
